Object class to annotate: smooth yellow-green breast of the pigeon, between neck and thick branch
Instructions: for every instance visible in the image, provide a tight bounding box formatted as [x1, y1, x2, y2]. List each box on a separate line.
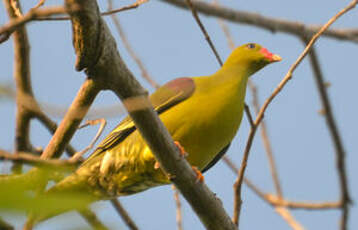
[160, 77, 246, 169]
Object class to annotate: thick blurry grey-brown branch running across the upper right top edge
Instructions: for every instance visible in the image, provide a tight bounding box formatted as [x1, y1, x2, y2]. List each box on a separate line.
[162, 0, 358, 43]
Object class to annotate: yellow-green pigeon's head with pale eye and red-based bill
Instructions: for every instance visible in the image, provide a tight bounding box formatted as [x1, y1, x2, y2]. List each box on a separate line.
[223, 43, 282, 75]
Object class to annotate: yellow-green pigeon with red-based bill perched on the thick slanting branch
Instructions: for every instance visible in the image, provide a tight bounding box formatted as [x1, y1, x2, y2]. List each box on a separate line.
[28, 43, 281, 225]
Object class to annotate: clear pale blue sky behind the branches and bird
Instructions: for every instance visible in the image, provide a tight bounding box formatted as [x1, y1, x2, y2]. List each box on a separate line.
[0, 0, 358, 230]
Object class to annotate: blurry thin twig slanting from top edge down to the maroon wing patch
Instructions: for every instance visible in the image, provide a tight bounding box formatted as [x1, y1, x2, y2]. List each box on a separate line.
[108, 0, 160, 89]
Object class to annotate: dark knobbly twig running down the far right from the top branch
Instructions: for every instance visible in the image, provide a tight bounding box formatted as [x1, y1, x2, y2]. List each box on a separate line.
[302, 38, 351, 230]
